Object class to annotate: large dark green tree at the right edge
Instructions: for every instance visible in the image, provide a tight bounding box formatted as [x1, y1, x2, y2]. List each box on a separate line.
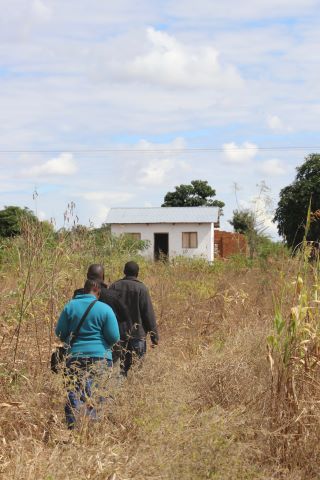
[273, 153, 320, 248]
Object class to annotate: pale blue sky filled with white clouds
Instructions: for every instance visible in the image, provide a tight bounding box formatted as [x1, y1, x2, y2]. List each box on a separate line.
[0, 0, 320, 236]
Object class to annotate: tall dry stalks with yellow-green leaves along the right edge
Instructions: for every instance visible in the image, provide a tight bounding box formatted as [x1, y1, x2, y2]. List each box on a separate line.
[268, 209, 320, 475]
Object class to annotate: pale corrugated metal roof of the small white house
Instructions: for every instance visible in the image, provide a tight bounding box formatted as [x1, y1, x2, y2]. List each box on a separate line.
[106, 207, 219, 224]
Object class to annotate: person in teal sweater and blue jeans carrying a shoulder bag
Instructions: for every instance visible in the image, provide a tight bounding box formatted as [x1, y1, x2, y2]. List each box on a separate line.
[55, 280, 120, 429]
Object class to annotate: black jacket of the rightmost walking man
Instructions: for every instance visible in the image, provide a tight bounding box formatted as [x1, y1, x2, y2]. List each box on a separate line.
[109, 277, 159, 345]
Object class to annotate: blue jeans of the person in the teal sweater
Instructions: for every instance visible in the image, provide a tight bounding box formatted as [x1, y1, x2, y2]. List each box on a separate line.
[64, 357, 112, 430]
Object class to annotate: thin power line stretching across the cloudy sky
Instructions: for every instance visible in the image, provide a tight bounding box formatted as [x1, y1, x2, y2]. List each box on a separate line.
[0, 145, 320, 154]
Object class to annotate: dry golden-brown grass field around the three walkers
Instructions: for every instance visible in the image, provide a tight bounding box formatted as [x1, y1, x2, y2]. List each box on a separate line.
[0, 223, 320, 480]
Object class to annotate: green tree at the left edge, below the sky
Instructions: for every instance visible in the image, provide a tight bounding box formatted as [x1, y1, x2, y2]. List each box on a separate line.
[0, 205, 38, 237]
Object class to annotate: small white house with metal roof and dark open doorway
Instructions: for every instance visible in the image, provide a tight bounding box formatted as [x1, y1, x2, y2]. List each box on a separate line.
[106, 207, 220, 262]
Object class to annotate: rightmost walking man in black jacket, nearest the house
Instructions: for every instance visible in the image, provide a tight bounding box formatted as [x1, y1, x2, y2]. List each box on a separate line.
[109, 262, 159, 375]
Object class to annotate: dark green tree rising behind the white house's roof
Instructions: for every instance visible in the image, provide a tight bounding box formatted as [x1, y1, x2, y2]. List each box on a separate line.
[161, 180, 224, 208]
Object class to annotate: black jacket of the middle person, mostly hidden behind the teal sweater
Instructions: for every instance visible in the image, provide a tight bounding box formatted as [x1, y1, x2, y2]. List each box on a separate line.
[73, 283, 132, 342]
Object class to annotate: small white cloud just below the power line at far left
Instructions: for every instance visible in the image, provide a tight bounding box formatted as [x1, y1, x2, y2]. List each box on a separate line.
[21, 153, 78, 177]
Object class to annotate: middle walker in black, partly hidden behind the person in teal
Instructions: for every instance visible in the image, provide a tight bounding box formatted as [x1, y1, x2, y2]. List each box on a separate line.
[73, 263, 132, 362]
